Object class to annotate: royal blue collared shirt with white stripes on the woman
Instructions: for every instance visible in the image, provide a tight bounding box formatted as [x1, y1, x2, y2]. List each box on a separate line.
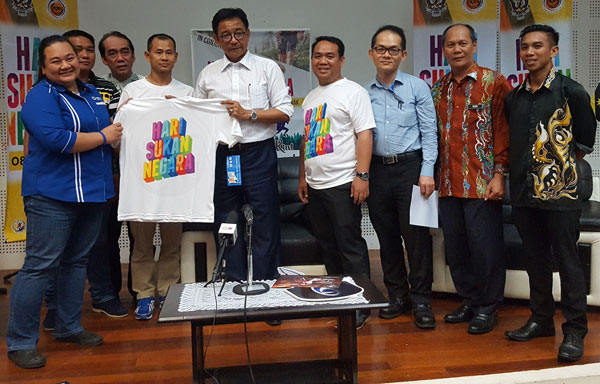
[21, 78, 114, 203]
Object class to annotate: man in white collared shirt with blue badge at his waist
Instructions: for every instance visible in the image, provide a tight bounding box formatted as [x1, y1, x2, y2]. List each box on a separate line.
[194, 8, 293, 280]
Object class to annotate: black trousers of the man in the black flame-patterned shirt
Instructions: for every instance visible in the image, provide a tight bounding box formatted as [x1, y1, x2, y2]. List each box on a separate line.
[512, 207, 587, 337]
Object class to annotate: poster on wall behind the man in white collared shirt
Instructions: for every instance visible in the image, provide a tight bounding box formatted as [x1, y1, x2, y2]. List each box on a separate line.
[192, 29, 312, 157]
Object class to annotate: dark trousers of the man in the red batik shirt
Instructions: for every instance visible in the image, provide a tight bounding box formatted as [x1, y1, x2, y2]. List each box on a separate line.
[439, 197, 506, 314]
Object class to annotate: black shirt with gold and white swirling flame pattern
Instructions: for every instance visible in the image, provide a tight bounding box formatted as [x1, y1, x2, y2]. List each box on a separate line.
[505, 69, 596, 210]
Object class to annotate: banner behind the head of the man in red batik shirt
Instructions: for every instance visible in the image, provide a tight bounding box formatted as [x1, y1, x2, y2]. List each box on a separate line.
[408, 0, 499, 87]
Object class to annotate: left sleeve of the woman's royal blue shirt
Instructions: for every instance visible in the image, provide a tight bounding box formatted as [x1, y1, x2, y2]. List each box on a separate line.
[21, 88, 78, 153]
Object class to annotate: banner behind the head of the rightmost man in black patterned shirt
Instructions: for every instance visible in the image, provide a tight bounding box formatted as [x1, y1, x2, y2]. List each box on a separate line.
[500, 0, 573, 87]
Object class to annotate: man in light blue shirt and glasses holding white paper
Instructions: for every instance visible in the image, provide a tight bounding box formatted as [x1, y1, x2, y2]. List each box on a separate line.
[366, 25, 437, 329]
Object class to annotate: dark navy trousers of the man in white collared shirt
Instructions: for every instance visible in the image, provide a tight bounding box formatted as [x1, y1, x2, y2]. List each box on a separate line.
[214, 139, 281, 281]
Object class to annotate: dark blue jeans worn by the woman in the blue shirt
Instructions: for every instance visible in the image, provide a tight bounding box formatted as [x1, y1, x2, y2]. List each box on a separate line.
[6, 195, 104, 352]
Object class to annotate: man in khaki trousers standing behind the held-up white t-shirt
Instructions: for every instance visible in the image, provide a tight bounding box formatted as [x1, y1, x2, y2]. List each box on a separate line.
[120, 33, 193, 320]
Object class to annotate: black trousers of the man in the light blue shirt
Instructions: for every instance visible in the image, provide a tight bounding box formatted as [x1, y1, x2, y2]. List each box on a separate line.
[368, 154, 433, 304]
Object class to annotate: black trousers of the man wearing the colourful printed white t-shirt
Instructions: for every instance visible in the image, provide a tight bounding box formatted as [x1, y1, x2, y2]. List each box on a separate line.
[306, 183, 371, 276]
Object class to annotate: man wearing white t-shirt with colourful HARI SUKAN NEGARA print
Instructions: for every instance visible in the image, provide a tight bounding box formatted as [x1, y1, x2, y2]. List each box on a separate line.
[298, 36, 375, 328]
